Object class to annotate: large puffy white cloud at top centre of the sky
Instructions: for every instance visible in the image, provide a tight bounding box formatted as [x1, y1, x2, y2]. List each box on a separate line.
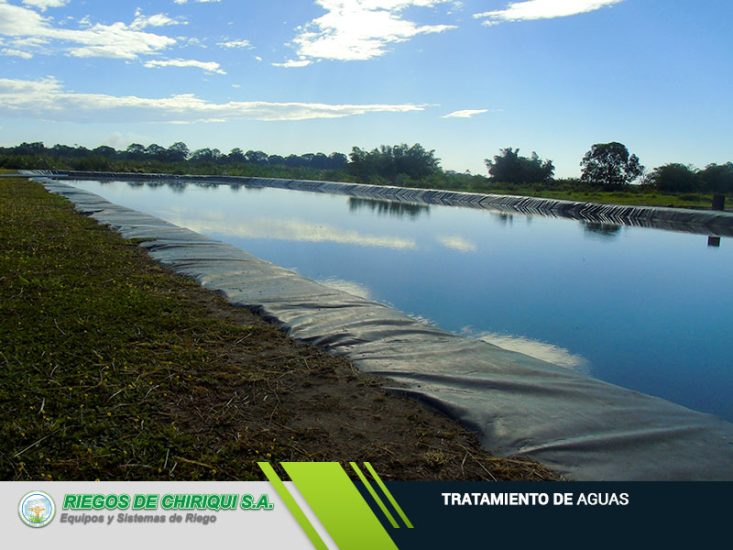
[279, 0, 455, 67]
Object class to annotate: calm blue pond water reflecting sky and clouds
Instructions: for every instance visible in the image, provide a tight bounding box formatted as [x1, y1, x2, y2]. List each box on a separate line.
[64, 182, 733, 420]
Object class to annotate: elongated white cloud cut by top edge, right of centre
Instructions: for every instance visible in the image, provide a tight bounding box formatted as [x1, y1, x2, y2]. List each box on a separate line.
[474, 0, 623, 26]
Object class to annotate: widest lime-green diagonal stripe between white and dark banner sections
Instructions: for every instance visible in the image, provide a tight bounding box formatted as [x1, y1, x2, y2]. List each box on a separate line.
[282, 462, 397, 550]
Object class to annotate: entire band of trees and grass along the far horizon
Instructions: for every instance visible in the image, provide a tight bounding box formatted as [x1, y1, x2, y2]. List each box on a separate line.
[0, 142, 733, 207]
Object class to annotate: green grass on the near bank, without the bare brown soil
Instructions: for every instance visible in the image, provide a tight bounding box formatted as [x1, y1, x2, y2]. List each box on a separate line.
[0, 181, 265, 479]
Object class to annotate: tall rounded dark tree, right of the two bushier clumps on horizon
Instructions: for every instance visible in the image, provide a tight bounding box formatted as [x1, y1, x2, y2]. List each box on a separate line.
[580, 141, 644, 189]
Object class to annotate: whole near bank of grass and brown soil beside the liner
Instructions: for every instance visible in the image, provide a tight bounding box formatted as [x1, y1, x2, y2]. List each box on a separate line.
[0, 179, 553, 480]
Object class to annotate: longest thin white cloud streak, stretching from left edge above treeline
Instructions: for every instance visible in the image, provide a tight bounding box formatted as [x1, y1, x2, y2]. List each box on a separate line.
[0, 78, 425, 123]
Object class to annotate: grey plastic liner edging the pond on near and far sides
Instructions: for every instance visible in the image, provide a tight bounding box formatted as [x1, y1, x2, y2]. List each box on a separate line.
[31, 173, 733, 481]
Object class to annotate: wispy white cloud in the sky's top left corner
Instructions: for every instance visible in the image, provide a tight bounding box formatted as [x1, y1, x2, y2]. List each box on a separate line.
[0, 0, 176, 59]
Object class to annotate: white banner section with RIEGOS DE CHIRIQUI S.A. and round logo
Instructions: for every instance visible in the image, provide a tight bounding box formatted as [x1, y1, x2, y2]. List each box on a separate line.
[0, 482, 320, 550]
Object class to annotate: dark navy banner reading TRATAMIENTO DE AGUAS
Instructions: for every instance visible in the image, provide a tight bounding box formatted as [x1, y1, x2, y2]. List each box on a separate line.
[387, 482, 733, 550]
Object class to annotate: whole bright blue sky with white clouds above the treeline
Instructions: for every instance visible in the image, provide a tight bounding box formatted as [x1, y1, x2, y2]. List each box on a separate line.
[0, 0, 733, 176]
